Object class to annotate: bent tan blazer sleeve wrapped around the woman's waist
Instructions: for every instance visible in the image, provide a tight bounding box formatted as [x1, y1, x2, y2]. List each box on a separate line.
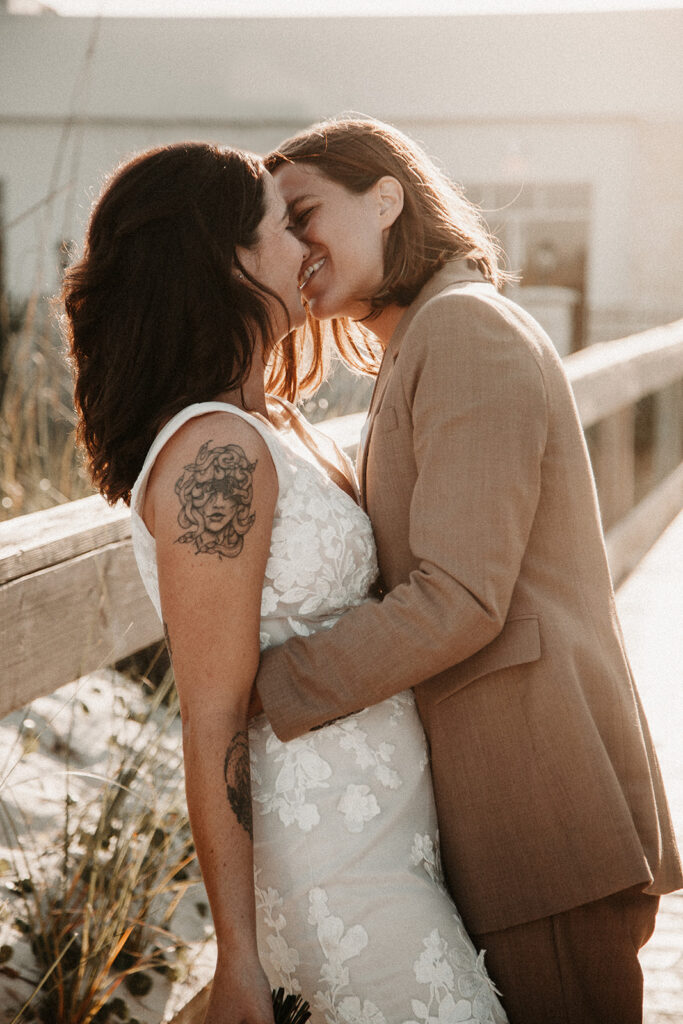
[256, 295, 548, 740]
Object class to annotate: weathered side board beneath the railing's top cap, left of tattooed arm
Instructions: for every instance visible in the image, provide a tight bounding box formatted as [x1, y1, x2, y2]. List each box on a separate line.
[0, 540, 162, 717]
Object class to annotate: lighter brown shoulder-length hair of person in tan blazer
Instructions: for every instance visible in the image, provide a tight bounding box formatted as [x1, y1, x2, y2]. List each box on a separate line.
[265, 117, 508, 372]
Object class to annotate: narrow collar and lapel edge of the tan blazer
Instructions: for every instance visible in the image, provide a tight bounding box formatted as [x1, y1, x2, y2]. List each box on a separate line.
[356, 259, 485, 511]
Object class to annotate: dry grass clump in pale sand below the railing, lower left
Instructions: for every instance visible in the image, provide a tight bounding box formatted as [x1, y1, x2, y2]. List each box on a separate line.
[0, 659, 200, 1024]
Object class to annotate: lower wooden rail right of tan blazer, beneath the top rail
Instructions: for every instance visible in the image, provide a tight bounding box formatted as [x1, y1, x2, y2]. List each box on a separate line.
[605, 463, 683, 587]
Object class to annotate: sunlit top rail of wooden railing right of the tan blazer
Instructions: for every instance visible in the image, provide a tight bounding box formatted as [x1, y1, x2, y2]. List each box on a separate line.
[564, 319, 683, 427]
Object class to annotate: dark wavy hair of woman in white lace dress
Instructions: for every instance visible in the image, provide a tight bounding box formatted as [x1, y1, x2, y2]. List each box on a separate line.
[60, 142, 314, 504]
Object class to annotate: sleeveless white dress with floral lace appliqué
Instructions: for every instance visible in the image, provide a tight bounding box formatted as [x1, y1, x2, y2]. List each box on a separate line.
[131, 402, 506, 1024]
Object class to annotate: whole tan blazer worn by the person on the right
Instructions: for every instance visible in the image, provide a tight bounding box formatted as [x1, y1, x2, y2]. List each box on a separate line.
[257, 261, 683, 934]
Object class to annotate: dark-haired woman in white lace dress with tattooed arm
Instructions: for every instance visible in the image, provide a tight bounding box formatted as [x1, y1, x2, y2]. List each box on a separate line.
[65, 145, 506, 1024]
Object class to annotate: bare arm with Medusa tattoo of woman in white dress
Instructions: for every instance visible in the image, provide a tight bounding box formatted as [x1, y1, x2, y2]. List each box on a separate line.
[144, 414, 278, 1024]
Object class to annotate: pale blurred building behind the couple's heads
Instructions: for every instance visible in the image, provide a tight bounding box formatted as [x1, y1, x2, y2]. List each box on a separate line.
[0, 9, 683, 352]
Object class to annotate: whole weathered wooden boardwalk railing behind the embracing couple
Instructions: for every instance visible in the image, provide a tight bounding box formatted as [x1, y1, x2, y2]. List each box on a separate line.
[0, 319, 683, 1024]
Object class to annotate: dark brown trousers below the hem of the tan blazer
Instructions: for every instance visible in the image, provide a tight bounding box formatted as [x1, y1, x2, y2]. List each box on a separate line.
[472, 887, 659, 1024]
